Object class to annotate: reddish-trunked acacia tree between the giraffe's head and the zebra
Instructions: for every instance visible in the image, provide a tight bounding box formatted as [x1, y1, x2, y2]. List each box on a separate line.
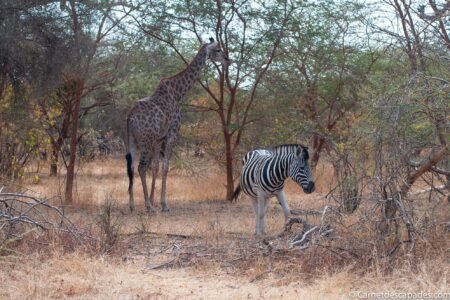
[132, 1, 299, 199]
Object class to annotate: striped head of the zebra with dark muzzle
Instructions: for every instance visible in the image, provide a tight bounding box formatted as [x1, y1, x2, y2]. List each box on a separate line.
[289, 145, 314, 194]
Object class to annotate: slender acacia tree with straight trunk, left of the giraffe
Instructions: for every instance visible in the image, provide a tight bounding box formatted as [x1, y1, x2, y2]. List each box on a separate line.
[58, 0, 138, 203]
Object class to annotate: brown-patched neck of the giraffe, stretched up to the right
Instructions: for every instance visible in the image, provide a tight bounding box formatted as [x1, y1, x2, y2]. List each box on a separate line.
[163, 45, 207, 101]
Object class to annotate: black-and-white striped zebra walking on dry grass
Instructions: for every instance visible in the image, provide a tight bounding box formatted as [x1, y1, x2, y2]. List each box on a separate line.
[231, 144, 314, 236]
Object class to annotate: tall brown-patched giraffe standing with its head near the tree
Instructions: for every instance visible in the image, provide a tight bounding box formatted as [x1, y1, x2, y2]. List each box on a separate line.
[125, 38, 231, 213]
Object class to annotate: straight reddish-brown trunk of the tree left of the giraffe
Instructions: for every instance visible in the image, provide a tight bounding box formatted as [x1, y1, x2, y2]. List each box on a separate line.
[65, 79, 84, 204]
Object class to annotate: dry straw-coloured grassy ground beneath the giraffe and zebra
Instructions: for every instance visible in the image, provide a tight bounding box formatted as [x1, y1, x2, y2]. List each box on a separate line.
[0, 160, 450, 299]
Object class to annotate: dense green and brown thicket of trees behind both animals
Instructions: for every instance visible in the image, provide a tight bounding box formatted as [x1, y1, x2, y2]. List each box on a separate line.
[0, 0, 450, 219]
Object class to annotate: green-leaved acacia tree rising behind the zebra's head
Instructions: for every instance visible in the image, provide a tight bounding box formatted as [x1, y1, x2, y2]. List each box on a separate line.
[264, 1, 374, 167]
